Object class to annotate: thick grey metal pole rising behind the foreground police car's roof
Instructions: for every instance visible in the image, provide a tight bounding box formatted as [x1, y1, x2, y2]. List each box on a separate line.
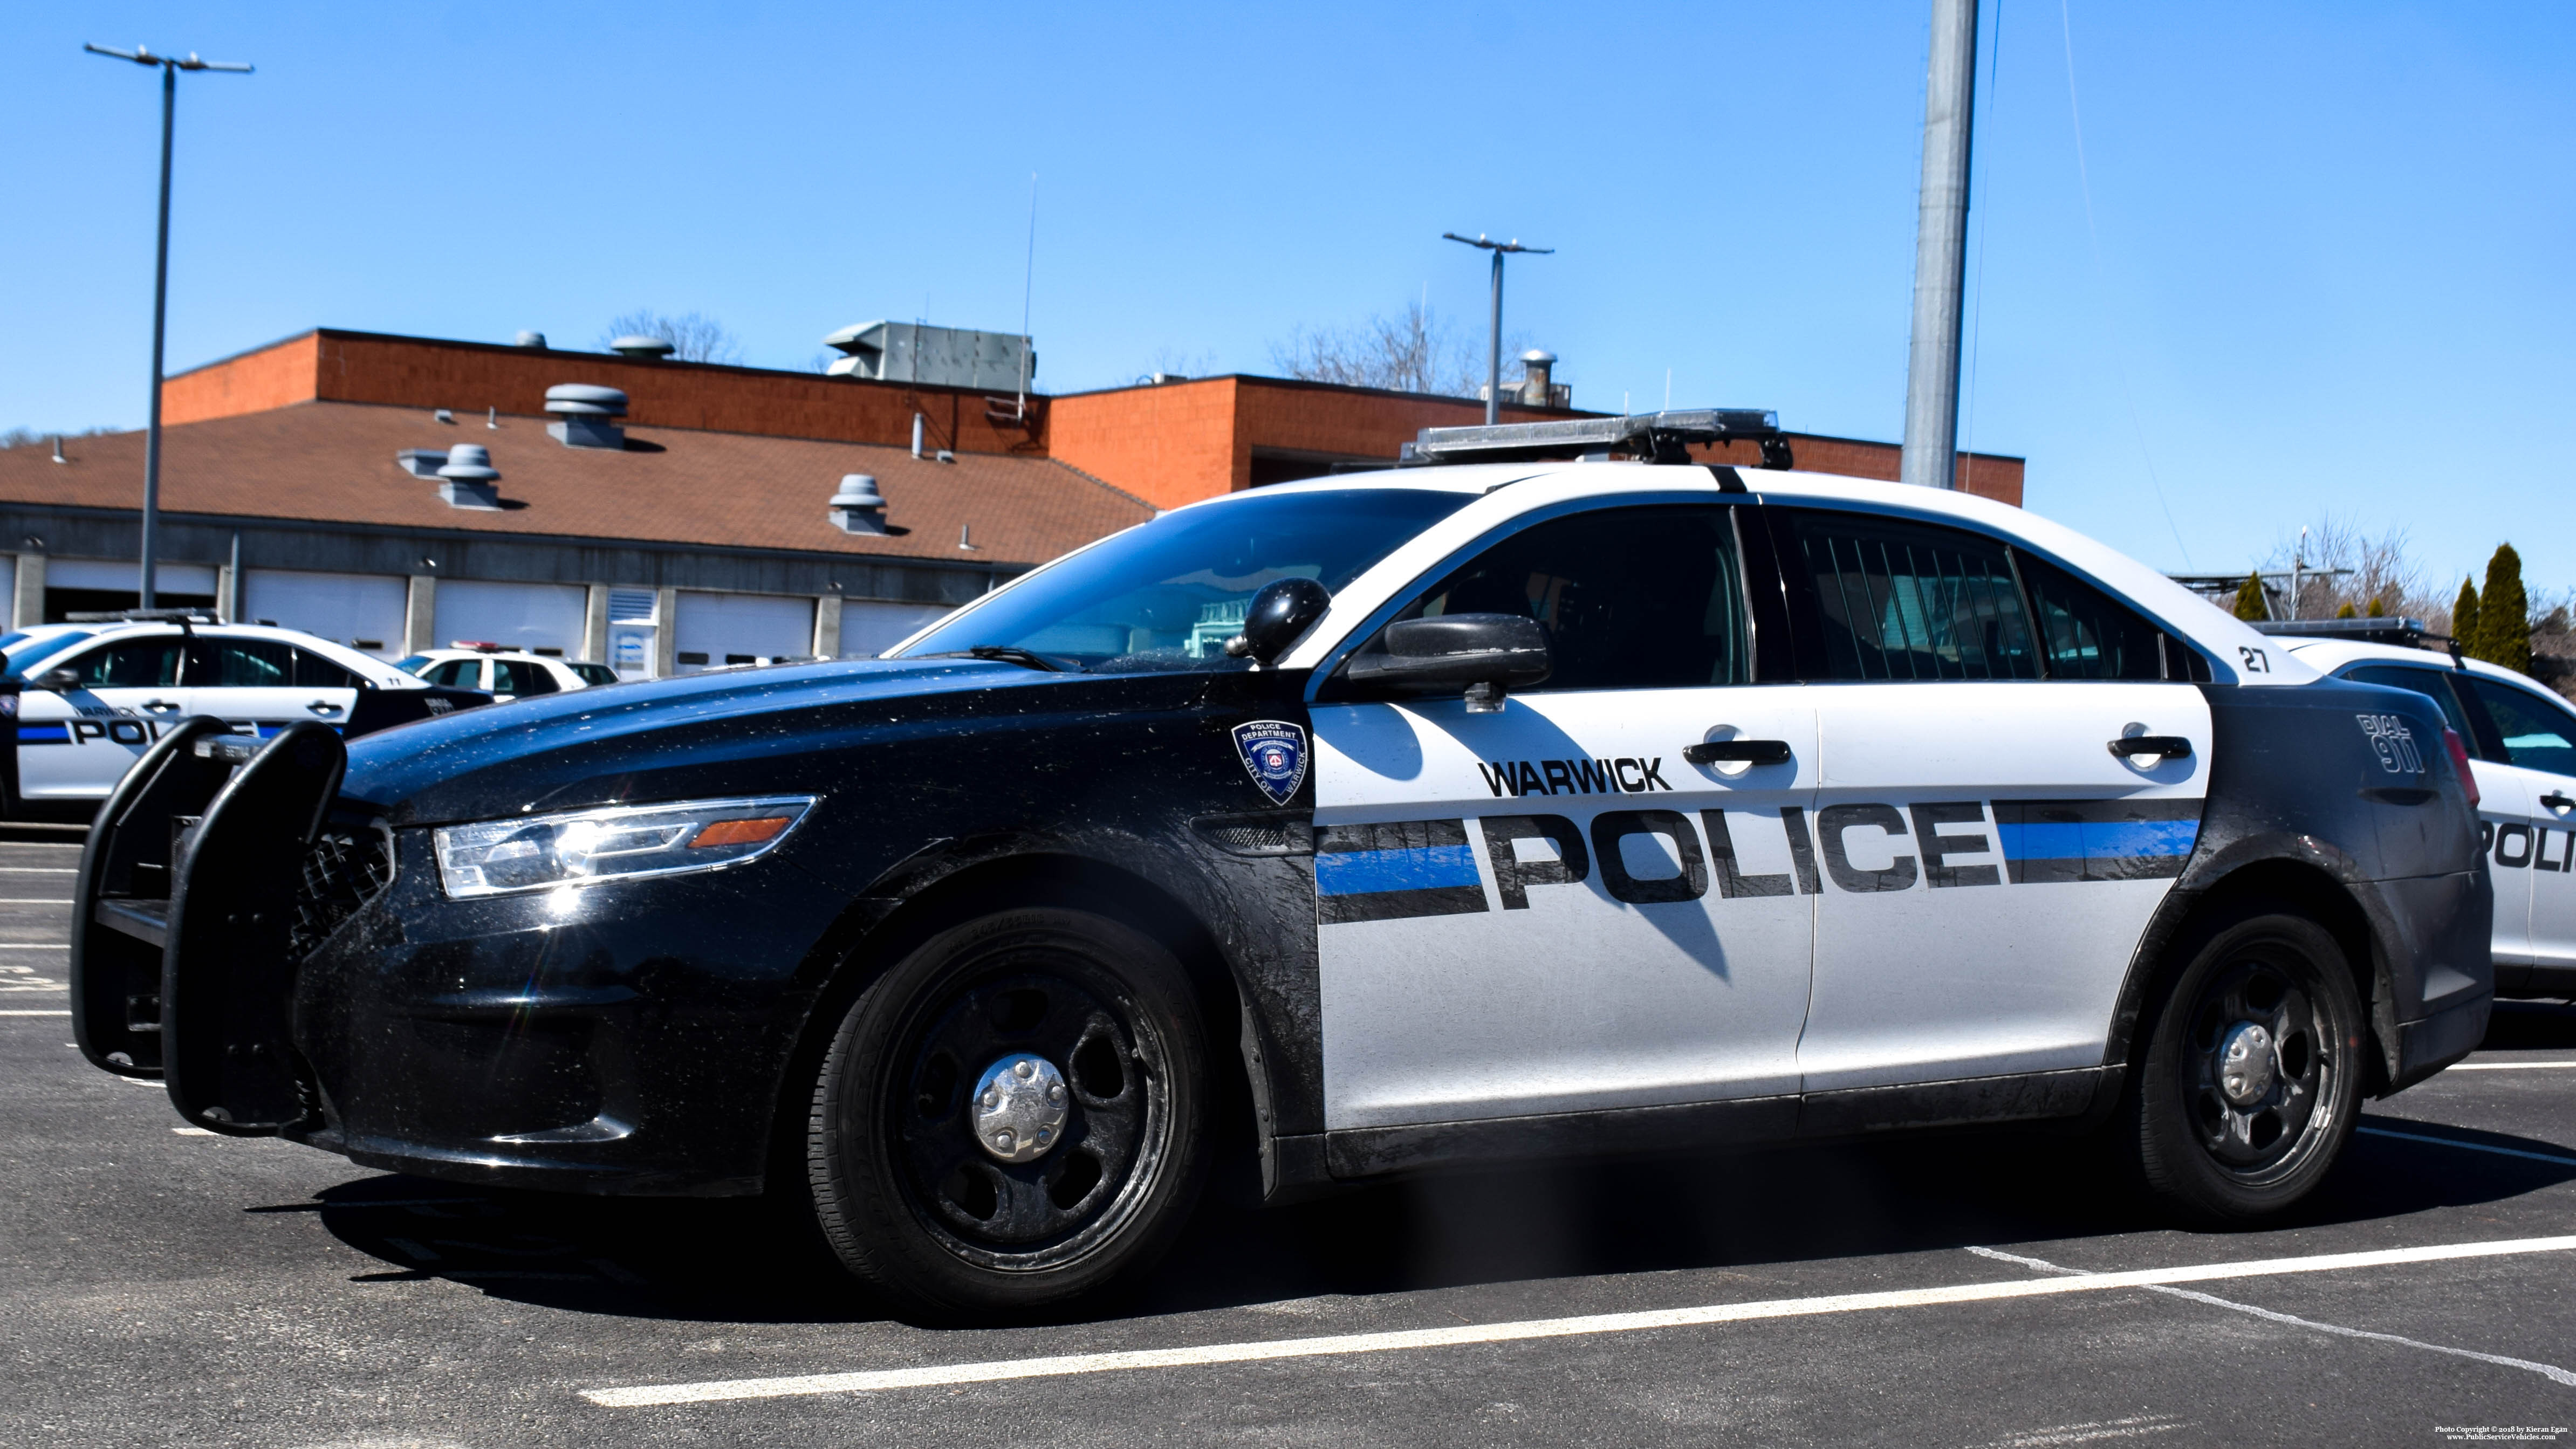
[1901, 0, 1978, 489]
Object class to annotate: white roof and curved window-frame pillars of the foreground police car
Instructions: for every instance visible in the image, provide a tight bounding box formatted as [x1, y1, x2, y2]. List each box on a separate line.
[1185, 463, 2321, 685]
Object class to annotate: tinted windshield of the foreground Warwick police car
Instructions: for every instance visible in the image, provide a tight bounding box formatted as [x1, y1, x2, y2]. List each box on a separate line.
[904, 489, 1476, 672]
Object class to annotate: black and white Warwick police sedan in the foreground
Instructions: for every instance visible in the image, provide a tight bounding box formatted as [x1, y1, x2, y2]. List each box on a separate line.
[72, 412, 2493, 1315]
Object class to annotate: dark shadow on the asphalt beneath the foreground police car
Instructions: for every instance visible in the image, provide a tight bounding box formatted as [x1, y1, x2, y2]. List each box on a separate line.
[292, 1115, 2576, 1323]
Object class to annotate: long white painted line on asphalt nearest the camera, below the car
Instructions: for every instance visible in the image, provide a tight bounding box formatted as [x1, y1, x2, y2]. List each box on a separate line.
[582, 1238, 2576, 1408]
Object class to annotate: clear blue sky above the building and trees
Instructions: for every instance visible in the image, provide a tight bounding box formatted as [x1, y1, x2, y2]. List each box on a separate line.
[0, 0, 2576, 589]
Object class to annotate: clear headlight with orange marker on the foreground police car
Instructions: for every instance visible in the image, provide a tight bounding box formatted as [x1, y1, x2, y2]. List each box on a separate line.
[433, 795, 817, 898]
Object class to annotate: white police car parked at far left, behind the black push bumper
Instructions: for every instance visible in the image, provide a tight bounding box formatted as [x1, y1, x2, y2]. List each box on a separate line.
[0, 610, 484, 821]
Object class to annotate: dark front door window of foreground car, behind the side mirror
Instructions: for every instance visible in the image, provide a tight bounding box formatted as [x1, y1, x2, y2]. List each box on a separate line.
[1401, 504, 1752, 690]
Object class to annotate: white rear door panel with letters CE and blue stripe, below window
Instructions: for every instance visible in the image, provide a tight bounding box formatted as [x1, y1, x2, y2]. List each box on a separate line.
[1798, 679, 2210, 1091]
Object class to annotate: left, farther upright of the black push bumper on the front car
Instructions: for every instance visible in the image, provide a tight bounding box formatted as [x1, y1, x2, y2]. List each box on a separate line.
[72, 716, 235, 1079]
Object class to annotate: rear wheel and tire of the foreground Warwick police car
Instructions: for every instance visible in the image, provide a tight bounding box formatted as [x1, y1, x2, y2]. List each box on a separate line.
[2120, 906, 2365, 1228]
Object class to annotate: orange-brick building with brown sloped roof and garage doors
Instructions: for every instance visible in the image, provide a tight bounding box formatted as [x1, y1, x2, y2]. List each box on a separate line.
[0, 329, 2022, 674]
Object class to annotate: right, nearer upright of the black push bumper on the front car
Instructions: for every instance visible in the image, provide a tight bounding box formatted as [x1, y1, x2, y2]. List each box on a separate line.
[162, 720, 348, 1138]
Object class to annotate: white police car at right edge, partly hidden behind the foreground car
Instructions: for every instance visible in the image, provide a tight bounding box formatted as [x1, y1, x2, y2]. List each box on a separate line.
[2254, 617, 2576, 999]
